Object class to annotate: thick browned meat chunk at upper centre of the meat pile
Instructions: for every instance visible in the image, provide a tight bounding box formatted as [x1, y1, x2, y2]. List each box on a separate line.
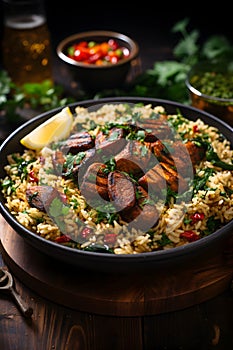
[115, 141, 151, 177]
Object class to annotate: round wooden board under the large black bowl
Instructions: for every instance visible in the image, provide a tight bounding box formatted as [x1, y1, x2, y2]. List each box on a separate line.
[0, 216, 233, 316]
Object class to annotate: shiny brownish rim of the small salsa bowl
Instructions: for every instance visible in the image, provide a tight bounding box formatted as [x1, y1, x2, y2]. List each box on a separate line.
[56, 30, 139, 70]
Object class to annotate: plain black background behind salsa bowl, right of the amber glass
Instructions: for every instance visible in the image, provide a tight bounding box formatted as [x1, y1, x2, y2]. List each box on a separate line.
[0, 0, 233, 72]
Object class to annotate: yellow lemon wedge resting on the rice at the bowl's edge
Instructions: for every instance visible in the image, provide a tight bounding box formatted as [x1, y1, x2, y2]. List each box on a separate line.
[20, 106, 74, 150]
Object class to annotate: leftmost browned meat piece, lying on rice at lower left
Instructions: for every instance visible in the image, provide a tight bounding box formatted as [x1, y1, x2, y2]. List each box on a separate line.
[26, 185, 67, 212]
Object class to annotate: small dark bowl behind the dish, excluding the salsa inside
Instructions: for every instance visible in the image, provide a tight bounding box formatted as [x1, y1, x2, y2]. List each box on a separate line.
[57, 30, 139, 91]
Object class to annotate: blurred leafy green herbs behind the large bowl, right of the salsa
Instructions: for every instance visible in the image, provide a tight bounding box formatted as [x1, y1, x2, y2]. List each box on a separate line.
[96, 18, 233, 104]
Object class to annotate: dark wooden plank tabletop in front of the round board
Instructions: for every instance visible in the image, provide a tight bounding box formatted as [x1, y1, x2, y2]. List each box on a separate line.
[0, 253, 233, 350]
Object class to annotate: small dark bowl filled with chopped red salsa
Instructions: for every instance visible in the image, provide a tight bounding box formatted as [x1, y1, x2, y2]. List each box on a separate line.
[56, 30, 139, 92]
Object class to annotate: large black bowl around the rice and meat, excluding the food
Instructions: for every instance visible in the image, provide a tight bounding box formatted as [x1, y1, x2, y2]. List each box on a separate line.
[0, 97, 233, 272]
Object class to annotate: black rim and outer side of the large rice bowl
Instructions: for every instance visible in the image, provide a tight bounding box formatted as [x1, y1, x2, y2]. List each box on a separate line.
[0, 96, 233, 272]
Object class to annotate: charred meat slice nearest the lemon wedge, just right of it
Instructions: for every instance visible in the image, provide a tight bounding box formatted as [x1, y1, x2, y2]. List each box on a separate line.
[61, 131, 94, 154]
